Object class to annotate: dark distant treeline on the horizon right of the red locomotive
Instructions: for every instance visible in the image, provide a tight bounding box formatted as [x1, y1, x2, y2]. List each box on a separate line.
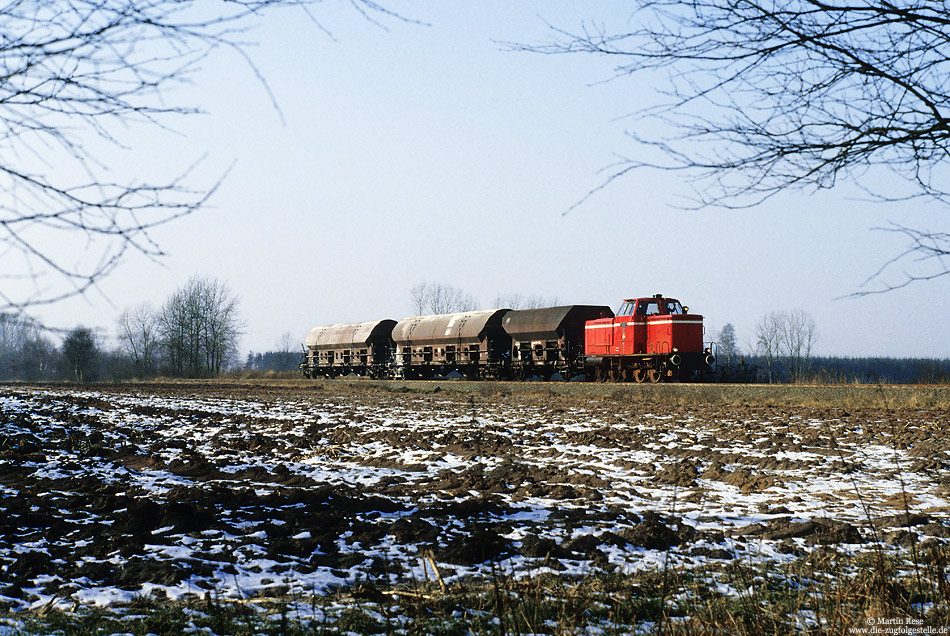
[732, 355, 950, 384]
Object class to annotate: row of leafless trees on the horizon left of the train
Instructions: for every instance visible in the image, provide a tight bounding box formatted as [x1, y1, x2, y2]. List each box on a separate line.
[0, 277, 243, 382]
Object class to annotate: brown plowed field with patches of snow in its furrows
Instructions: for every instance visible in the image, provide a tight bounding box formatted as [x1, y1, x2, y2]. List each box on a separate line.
[0, 382, 950, 623]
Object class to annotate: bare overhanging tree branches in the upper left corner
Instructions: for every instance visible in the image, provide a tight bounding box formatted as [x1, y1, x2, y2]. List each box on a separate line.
[0, 0, 393, 310]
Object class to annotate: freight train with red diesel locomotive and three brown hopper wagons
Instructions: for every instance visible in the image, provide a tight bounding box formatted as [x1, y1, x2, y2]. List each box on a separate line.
[301, 294, 715, 382]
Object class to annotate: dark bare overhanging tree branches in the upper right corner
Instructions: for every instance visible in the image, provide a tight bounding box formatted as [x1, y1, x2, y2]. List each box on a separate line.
[515, 0, 950, 290]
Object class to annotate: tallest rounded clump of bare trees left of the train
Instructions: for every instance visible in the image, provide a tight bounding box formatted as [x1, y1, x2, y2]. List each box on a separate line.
[158, 278, 243, 377]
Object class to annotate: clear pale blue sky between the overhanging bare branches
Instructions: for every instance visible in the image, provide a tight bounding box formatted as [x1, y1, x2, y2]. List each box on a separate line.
[22, 2, 950, 357]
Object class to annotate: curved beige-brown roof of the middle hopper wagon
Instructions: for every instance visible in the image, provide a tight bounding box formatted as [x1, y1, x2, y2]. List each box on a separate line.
[393, 309, 509, 346]
